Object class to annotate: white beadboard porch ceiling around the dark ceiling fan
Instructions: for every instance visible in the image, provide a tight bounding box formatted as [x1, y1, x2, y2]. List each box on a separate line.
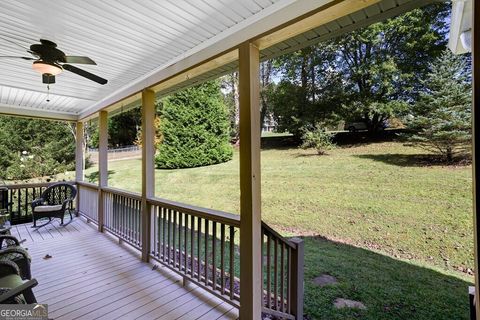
[0, 0, 290, 119]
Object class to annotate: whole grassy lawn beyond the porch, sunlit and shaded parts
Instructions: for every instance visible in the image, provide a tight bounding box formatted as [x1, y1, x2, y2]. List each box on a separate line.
[87, 143, 473, 319]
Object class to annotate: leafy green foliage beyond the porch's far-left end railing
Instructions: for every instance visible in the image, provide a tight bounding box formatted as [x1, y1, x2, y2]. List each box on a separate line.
[0, 116, 75, 180]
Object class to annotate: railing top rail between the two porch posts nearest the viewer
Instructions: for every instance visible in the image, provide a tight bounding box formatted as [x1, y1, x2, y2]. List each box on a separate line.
[147, 197, 240, 227]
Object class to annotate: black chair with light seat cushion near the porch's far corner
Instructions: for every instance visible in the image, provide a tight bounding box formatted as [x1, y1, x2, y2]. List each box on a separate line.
[32, 182, 77, 228]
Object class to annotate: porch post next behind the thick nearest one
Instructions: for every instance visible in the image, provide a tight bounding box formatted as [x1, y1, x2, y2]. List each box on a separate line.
[142, 89, 155, 262]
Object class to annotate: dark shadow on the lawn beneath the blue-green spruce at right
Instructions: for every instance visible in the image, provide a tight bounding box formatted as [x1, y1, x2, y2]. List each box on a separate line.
[353, 153, 470, 167]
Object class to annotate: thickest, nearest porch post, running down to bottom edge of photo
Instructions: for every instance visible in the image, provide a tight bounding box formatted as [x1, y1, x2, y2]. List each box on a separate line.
[239, 42, 262, 320]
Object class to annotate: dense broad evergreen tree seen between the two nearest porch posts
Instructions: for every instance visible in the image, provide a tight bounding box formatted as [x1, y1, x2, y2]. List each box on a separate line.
[155, 81, 233, 169]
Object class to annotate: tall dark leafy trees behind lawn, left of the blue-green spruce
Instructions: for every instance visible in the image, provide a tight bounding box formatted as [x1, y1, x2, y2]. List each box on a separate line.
[271, 3, 449, 135]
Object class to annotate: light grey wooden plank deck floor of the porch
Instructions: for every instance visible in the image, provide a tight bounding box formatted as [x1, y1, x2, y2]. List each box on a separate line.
[12, 218, 238, 320]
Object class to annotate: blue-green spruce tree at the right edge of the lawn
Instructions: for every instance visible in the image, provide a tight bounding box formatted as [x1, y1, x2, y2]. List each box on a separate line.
[407, 50, 472, 162]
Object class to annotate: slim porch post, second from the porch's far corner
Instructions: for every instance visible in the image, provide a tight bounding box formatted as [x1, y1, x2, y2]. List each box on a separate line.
[98, 111, 108, 232]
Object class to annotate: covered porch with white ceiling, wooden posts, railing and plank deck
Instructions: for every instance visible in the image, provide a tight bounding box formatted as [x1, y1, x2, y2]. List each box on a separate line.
[0, 0, 478, 319]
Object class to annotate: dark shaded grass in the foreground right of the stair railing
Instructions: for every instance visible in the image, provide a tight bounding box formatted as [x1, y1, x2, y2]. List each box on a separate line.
[304, 237, 471, 320]
